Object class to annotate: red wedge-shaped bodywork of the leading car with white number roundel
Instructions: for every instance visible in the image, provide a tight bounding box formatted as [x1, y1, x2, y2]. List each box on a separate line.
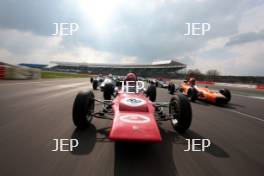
[109, 93, 161, 142]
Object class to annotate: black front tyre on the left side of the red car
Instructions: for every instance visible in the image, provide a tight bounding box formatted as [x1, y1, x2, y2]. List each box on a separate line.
[72, 91, 95, 129]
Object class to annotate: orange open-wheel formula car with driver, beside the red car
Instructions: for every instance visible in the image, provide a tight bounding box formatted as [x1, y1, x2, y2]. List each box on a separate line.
[179, 78, 231, 105]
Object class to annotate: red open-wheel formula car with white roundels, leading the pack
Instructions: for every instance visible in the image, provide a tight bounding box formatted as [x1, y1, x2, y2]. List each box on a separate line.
[73, 74, 192, 142]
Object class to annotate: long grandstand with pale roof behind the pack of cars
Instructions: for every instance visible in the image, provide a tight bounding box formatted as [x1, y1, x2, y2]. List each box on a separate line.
[50, 60, 186, 77]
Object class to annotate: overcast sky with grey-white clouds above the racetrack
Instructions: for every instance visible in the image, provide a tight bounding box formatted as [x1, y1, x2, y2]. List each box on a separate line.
[0, 0, 264, 76]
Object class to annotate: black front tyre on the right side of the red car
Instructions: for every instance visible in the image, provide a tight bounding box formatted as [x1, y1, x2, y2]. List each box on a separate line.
[169, 94, 192, 133]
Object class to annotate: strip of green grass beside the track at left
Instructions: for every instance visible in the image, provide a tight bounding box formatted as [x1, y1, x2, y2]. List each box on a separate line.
[41, 71, 90, 78]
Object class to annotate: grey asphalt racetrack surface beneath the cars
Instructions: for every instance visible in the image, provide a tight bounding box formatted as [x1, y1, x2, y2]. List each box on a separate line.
[0, 79, 264, 176]
